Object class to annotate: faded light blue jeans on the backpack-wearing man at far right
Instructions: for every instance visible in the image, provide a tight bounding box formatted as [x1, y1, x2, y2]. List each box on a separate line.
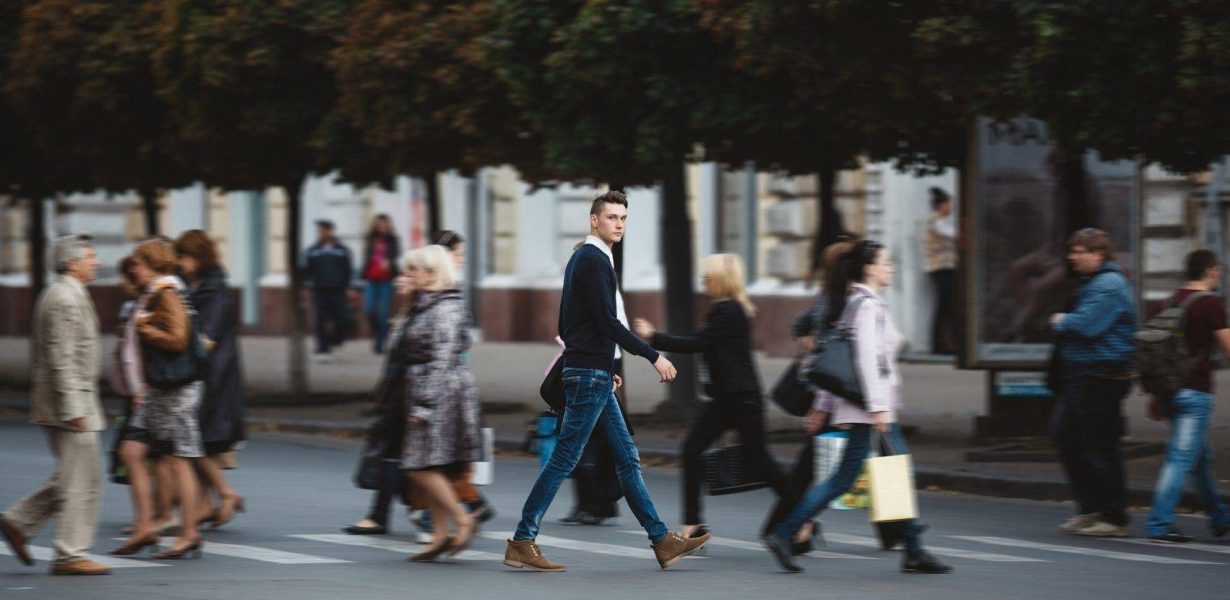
[1145, 390, 1230, 535]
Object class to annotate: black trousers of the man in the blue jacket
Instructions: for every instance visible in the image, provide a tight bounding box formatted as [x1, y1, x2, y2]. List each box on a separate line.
[1050, 376, 1132, 525]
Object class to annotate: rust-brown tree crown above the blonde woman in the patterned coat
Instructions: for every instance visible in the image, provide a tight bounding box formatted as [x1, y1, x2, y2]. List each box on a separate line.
[332, 0, 546, 230]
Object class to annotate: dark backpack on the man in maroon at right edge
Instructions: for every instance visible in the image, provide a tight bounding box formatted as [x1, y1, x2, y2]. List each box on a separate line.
[1137, 291, 1213, 401]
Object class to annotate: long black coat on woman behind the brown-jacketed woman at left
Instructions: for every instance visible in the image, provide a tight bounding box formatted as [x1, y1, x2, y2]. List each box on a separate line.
[188, 269, 247, 454]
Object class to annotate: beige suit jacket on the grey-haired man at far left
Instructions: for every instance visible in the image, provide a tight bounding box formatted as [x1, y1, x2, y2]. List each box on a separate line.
[30, 275, 105, 432]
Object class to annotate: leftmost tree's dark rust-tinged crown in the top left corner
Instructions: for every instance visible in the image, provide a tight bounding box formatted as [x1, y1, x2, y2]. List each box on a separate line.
[5, 0, 192, 235]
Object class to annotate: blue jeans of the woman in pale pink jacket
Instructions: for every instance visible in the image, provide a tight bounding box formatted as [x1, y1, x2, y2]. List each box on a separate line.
[772, 423, 923, 551]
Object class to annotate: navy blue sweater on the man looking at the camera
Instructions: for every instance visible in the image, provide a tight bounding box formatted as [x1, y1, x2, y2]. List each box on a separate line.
[560, 243, 658, 371]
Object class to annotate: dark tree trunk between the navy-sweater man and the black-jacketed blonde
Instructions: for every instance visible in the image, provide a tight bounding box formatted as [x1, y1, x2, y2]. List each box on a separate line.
[658, 162, 697, 418]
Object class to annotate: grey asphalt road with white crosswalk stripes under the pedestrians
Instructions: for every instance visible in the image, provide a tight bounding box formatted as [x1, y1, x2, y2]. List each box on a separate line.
[0, 418, 1230, 600]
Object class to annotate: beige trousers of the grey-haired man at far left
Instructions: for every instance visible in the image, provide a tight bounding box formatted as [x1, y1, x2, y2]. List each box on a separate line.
[4, 427, 102, 563]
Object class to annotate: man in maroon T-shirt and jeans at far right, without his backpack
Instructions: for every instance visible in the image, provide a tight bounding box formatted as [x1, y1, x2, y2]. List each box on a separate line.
[1145, 250, 1230, 543]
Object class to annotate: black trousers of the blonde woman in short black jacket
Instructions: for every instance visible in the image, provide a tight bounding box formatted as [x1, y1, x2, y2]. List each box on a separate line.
[684, 393, 790, 525]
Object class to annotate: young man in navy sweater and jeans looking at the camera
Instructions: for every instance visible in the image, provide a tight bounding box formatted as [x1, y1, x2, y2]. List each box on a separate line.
[504, 192, 708, 570]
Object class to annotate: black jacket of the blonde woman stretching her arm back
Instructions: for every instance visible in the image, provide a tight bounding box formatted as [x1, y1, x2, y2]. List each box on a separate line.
[651, 300, 760, 398]
